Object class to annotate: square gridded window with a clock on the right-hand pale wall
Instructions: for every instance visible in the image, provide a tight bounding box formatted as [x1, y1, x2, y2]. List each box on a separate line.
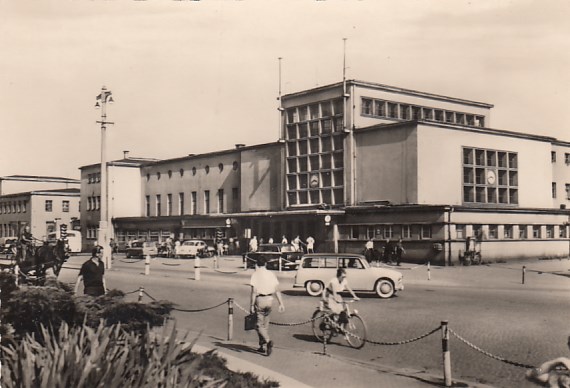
[463, 147, 519, 205]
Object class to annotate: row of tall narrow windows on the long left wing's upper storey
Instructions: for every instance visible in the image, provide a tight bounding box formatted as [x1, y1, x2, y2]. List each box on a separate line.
[145, 187, 239, 217]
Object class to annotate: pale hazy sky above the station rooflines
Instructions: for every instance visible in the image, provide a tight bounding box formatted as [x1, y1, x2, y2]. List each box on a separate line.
[0, 0, 570, 179]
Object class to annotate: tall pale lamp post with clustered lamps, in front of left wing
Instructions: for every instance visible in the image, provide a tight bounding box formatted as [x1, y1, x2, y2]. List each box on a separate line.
[95, 86, 114, 268]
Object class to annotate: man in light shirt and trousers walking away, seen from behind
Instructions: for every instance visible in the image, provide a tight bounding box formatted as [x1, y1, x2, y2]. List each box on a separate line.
[249, 258, 285, 356]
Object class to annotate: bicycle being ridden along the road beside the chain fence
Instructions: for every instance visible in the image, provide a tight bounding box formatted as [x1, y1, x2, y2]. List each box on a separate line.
[312, 299, 366, 349]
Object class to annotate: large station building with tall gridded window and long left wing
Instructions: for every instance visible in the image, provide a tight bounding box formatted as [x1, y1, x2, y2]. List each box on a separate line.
[77, 80, 570, 265]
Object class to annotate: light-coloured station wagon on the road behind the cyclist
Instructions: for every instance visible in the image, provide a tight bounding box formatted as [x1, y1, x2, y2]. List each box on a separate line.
[293, 253, 404, 298]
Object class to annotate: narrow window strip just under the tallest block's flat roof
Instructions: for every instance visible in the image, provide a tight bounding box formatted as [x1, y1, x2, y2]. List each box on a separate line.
[361, 97, 485, 127]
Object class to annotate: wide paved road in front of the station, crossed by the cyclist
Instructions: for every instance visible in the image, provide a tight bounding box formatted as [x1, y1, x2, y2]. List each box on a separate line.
[60, 257, 570, 387]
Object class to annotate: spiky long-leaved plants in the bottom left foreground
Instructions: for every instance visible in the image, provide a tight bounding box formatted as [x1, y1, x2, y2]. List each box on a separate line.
[2, 323, 278, 388]
